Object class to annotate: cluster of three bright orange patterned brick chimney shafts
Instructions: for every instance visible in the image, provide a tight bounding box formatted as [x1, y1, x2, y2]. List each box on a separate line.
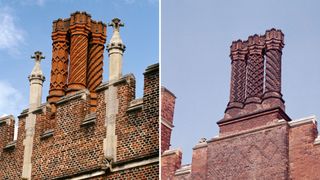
[47, 12, 106, 111]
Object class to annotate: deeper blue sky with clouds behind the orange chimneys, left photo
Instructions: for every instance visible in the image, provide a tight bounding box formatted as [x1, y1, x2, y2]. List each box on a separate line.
[0, 0, 159, 116]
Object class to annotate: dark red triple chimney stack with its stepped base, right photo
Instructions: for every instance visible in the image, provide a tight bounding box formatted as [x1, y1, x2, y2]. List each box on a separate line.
[218, 29, 290, 134]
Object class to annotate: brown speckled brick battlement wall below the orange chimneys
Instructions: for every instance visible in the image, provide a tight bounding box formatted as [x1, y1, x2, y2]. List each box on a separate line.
[0, 12, 159, 179]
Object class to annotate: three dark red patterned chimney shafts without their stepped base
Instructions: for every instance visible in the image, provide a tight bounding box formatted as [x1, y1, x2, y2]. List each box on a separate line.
[225, 29, 284, 118]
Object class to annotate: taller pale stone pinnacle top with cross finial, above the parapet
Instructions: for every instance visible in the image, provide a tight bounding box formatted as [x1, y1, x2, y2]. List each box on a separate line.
[107, 18, 126, 81]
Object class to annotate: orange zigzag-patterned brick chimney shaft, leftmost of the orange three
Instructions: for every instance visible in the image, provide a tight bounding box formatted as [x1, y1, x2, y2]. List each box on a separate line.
[47, 19, 69, 104]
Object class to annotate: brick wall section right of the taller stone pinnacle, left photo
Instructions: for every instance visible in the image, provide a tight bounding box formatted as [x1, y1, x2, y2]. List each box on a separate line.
[116, 65, 159, 161]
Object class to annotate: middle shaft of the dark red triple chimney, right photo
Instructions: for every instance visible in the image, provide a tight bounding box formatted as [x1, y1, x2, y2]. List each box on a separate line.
[246, 35, 264, 104]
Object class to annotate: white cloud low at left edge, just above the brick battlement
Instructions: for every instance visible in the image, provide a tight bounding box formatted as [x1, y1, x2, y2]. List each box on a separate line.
[0, 80, 23, 116]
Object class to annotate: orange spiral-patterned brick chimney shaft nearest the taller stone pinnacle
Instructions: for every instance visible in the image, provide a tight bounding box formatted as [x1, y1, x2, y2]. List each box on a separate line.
[87, 21, 106, 111]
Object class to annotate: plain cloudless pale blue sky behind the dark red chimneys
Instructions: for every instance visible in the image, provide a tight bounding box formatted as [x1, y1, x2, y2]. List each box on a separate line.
[161, 0, 320, 163]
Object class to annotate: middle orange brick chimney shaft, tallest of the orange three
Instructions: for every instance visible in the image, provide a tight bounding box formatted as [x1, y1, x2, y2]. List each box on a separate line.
[67, 12, 91, 94]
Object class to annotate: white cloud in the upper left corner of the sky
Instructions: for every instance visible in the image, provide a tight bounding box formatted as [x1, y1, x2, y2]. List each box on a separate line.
[0, 7, 25, 54]
